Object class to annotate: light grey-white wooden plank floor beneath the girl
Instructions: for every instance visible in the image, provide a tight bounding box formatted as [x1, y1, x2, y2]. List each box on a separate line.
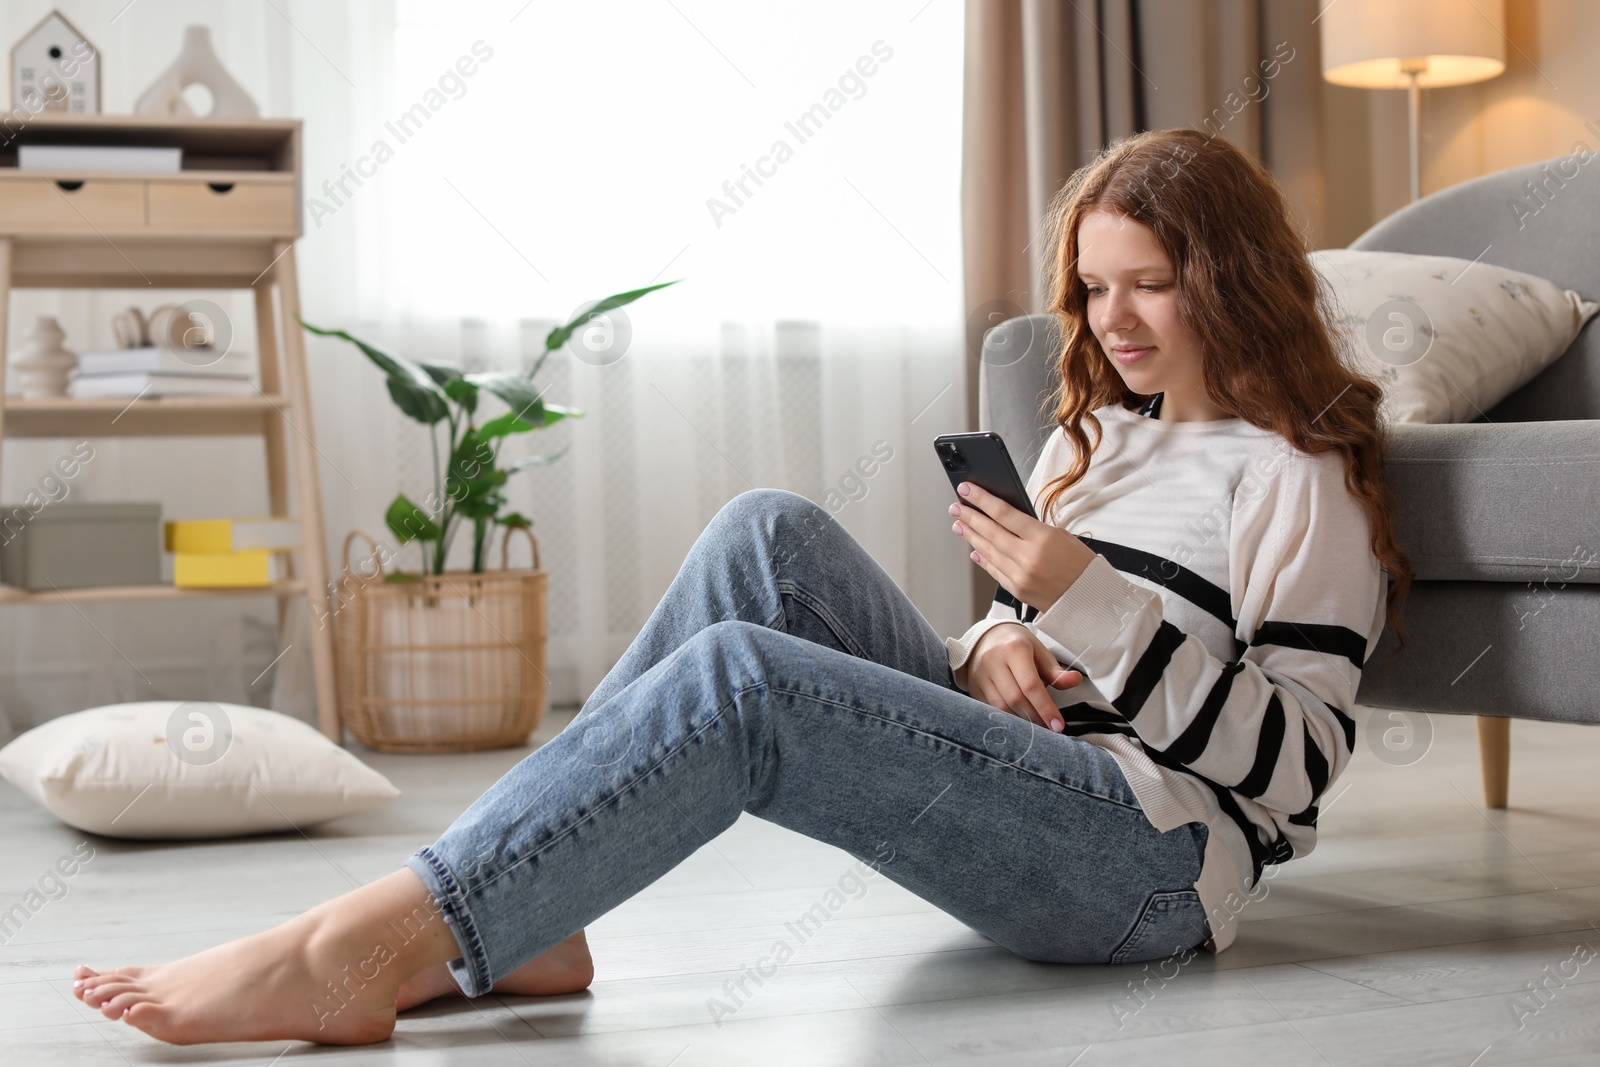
[0, 709, 1600, 1067]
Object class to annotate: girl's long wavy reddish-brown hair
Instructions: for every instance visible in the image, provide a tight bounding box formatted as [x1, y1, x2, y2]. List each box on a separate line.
[1042, 130, 1413, 659]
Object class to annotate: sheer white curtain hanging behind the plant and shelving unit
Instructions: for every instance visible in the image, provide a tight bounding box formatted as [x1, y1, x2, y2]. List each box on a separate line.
[0, 0, 973, 725]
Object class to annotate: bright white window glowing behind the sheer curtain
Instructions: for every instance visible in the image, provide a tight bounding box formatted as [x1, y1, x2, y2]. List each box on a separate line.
[356, 0, 962, 326]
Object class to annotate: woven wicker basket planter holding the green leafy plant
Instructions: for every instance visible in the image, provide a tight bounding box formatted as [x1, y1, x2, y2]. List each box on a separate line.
[334, 528, 549, 752]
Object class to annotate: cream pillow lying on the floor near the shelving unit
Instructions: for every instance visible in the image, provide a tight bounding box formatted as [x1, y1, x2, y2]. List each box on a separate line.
[0, 701, 400, 838]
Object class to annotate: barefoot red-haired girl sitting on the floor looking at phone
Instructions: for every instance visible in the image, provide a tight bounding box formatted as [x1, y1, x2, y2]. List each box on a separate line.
[74, 130, 1410, 1045]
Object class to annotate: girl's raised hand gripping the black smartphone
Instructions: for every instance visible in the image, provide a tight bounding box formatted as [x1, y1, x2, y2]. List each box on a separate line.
[950, 482, 1094, 611]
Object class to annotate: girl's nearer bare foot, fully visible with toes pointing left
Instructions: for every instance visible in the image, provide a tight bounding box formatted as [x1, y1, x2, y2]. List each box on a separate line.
[72, 869, 459, 1045]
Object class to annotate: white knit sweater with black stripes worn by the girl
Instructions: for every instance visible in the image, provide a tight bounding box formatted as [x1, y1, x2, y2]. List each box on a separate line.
[946, 395, 1386, 952]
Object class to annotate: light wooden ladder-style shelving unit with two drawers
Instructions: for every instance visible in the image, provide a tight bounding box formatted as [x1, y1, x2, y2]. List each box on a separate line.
[0, 114, 342, 742]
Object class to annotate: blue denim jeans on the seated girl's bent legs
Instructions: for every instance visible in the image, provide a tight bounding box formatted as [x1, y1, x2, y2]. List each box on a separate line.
[406, 490, 1206, 995]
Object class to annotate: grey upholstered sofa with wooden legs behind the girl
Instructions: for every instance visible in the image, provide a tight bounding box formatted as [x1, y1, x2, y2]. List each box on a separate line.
[978, 157, 1600, 808]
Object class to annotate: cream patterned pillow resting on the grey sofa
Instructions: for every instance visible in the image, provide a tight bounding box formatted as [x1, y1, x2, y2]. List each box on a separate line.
[1310, 248, 1600, 422]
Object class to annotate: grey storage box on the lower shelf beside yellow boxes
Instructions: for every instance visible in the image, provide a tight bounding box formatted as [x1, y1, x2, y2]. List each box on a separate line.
[0, 502, 162, 592]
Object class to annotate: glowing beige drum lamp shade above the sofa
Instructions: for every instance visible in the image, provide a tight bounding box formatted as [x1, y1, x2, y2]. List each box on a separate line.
[1317, 0, 1506, 90]
